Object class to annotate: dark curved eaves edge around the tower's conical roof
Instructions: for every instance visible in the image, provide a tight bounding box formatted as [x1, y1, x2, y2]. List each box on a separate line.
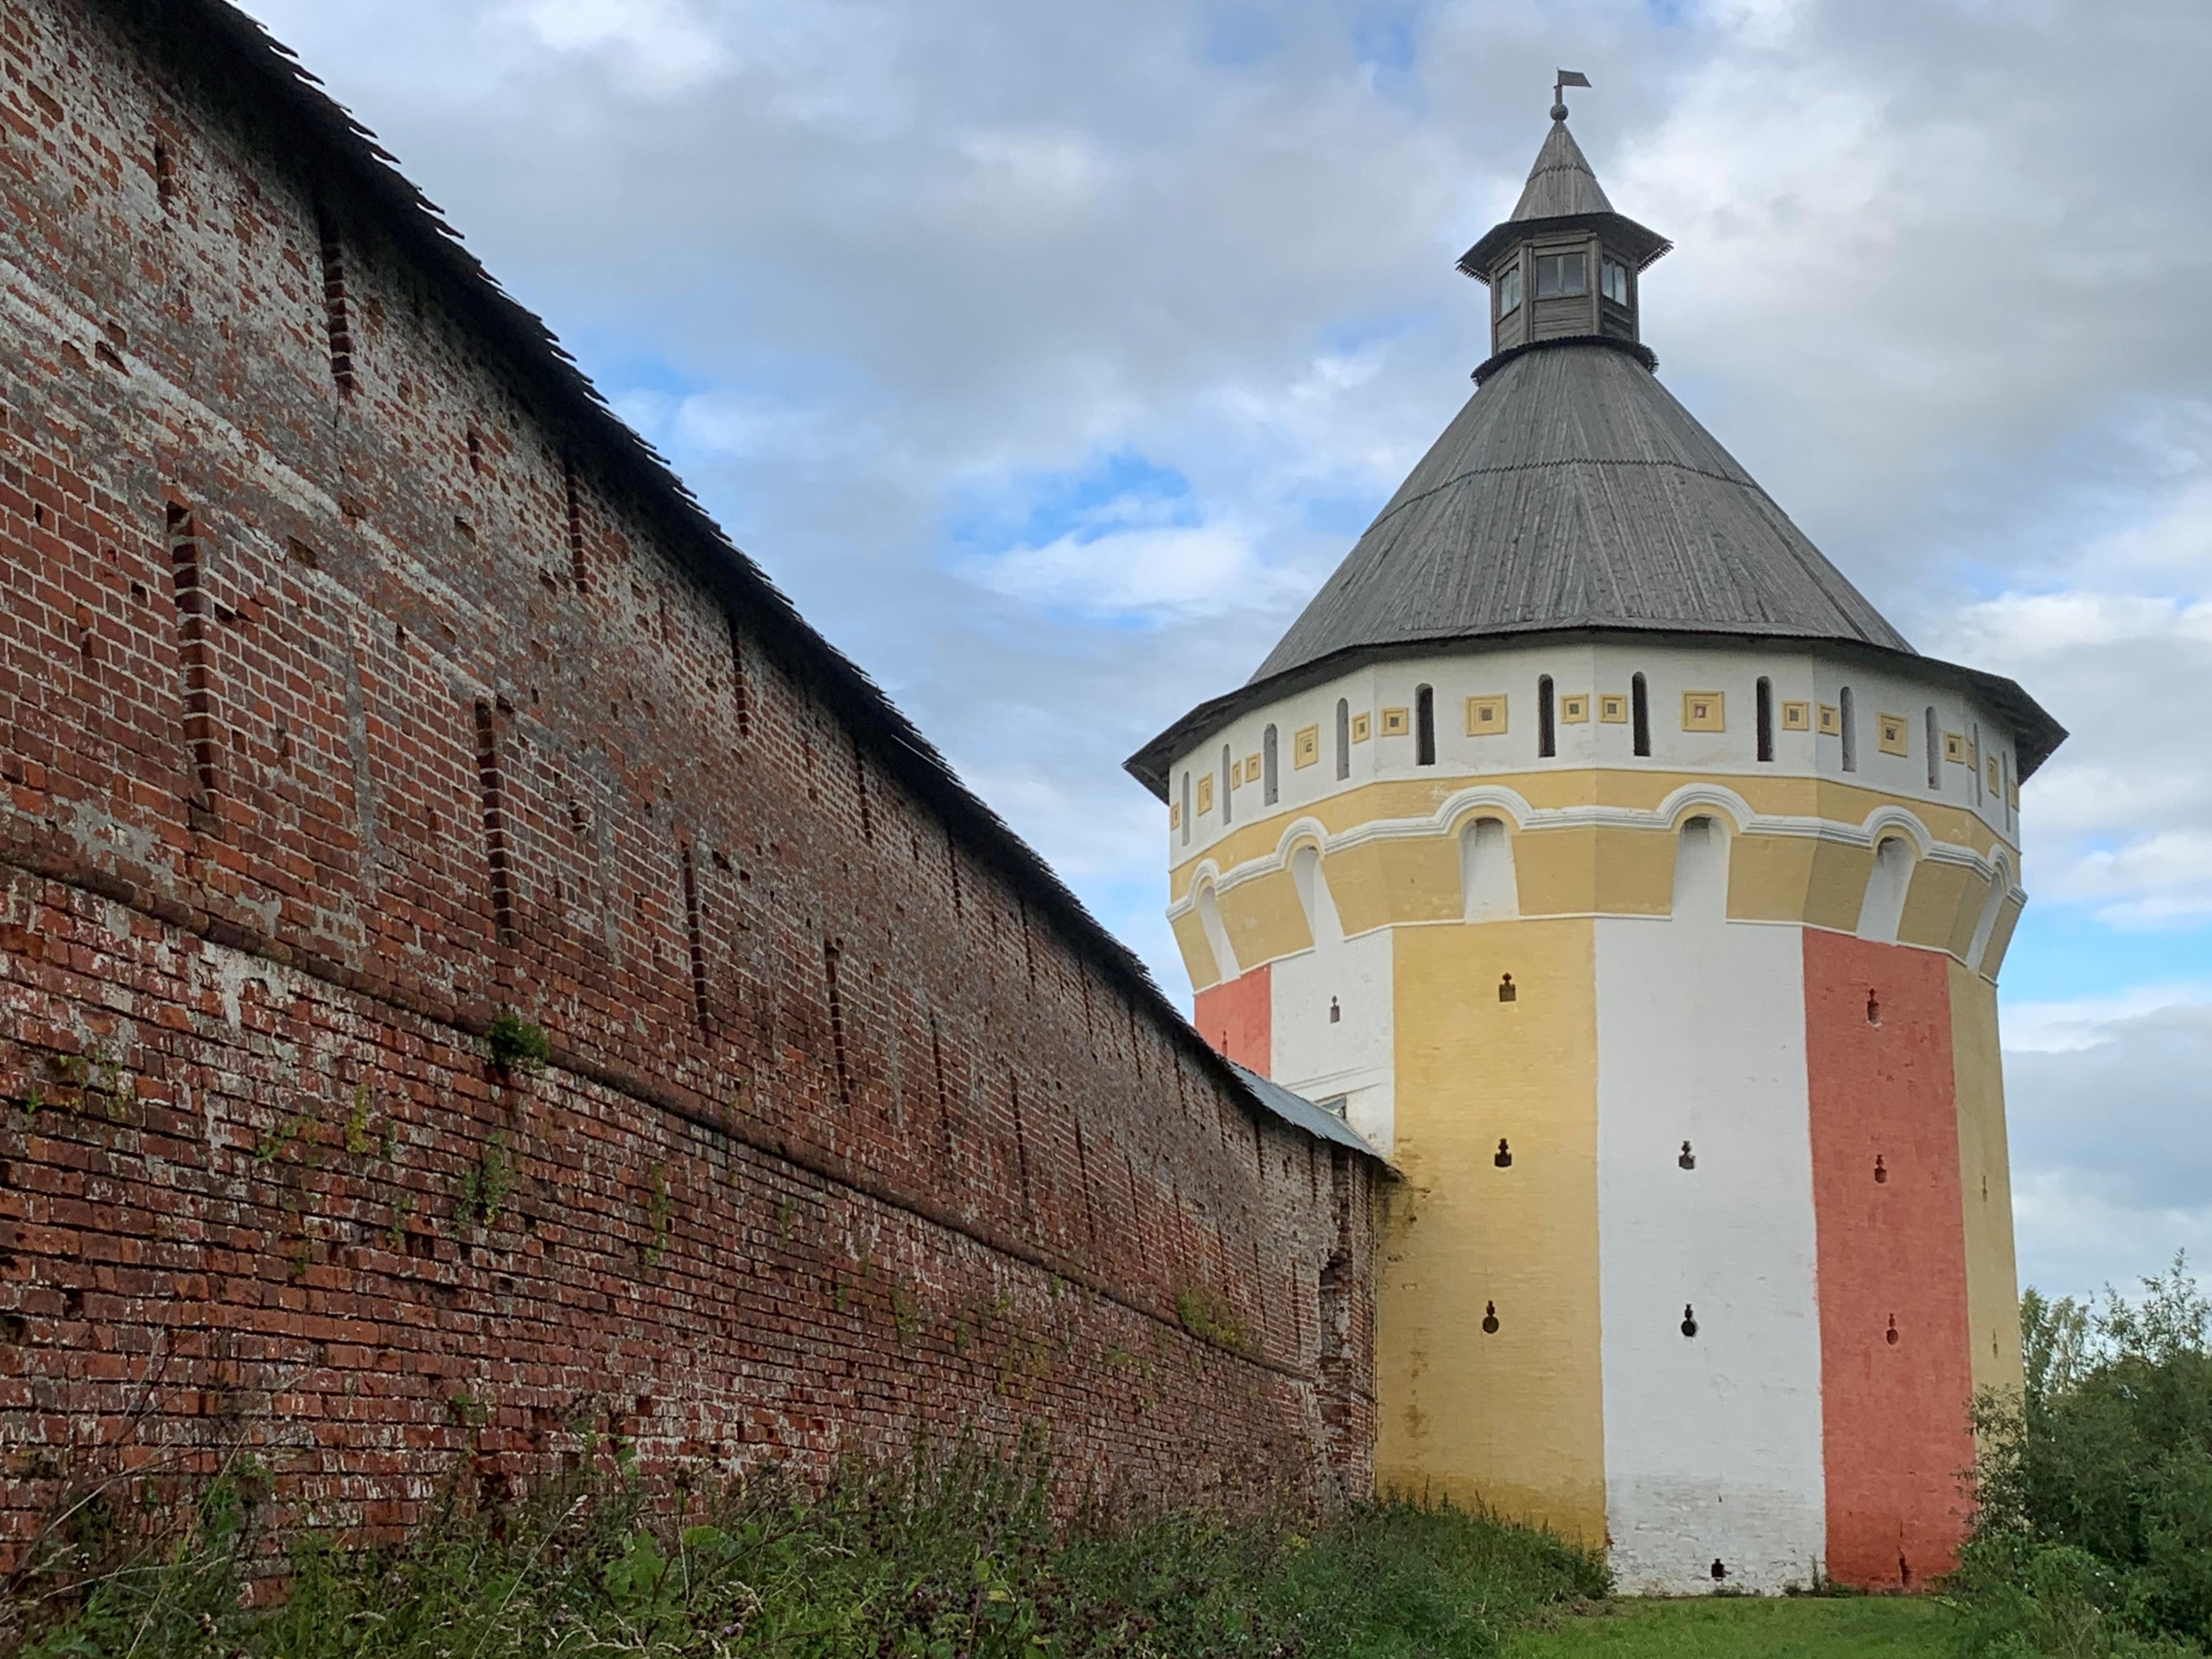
[1121, 617, 2068, 801]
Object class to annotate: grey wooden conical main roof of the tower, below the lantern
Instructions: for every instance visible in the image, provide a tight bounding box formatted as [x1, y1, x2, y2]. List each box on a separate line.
[1252, 343, 1911, 681]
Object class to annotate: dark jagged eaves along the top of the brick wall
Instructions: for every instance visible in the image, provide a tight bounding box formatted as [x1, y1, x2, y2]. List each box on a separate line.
[116, 0, 1380, 1168]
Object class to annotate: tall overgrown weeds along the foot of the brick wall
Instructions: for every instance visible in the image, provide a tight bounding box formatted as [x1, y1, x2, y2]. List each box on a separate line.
[4, 1453, 1606, 1659]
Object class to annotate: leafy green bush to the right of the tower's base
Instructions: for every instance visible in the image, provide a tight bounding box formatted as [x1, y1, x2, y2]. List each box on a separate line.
[1953, 1257, 2212, 1654]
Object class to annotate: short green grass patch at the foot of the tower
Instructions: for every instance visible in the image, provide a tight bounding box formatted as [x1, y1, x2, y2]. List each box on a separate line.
[1506, 1595, 1958, 1659]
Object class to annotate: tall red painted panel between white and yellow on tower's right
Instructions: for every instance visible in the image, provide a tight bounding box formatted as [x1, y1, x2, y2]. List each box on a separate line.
[1805, 927, 1973, 1588]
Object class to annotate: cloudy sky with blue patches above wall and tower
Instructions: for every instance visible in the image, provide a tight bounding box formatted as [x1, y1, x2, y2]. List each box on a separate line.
[248, 0, 2212, 1292]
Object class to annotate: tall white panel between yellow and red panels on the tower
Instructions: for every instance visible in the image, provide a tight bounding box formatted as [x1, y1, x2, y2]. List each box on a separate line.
[1597, 885, 1825, 1593]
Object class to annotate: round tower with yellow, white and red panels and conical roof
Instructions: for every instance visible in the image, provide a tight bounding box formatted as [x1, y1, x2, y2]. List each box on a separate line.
[1131, 91, 2064, 1590]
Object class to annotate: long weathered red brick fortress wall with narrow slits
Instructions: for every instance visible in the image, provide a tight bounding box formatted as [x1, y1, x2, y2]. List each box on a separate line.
[0, 0, 1380, 1559]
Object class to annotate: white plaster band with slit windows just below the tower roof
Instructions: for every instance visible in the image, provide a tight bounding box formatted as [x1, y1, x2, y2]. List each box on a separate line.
[1168, 639, 2019, 865]
